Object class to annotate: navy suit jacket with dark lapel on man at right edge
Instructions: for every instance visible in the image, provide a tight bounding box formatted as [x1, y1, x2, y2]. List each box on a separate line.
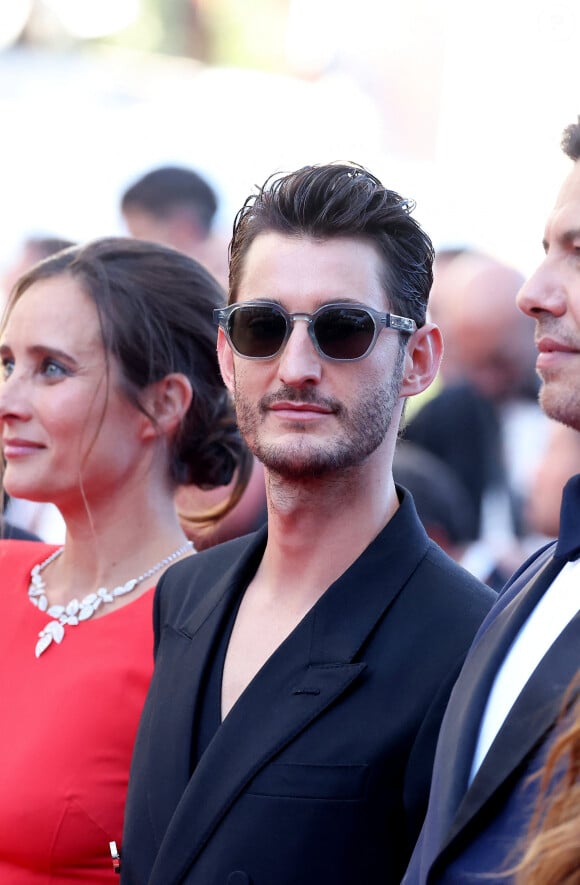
[403, 545, 580, 885]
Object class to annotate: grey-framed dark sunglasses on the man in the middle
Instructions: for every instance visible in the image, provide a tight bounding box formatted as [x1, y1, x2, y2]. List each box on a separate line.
[213, 301, 417, 360]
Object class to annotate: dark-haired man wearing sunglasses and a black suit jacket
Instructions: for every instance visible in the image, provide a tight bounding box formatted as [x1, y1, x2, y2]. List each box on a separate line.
[122, 164, 493, 885]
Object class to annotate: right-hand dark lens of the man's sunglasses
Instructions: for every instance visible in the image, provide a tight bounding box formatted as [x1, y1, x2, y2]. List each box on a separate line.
[314, 307, 375, 360]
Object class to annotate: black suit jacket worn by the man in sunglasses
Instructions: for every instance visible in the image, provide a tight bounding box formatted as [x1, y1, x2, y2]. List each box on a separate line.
[121, 495, 494, 885]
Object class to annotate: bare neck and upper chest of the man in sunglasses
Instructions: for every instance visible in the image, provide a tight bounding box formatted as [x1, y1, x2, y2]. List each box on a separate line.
[222, 469, 398, 716]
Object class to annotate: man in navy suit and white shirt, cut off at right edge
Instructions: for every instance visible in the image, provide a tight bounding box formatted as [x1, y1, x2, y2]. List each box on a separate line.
[404, 118, 580, 885]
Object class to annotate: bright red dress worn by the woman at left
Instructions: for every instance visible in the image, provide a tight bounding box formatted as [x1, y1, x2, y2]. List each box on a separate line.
[0, 541, 153, 885]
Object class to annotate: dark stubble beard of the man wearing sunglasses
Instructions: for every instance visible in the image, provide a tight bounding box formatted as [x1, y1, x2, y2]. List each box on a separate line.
[234, 348, 405, 481]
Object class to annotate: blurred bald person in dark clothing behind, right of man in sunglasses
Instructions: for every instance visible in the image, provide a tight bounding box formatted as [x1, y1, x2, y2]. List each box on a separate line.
[406, 249, 548, 588]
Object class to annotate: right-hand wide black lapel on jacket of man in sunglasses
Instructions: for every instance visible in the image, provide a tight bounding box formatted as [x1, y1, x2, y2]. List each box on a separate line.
[150, 490, 428, 885]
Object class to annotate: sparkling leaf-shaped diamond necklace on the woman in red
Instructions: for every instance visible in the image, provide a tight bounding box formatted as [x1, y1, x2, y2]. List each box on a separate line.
[28, 541, 193, 658]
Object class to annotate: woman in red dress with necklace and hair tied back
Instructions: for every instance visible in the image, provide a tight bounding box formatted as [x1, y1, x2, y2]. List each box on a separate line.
[0, 238, 251, 885]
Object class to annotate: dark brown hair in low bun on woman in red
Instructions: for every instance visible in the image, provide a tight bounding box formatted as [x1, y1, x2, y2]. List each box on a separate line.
[7, 237, 252, 521]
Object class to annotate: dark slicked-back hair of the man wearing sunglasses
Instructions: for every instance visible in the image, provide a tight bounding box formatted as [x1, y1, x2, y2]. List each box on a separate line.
[229, 163, 434, 326]
